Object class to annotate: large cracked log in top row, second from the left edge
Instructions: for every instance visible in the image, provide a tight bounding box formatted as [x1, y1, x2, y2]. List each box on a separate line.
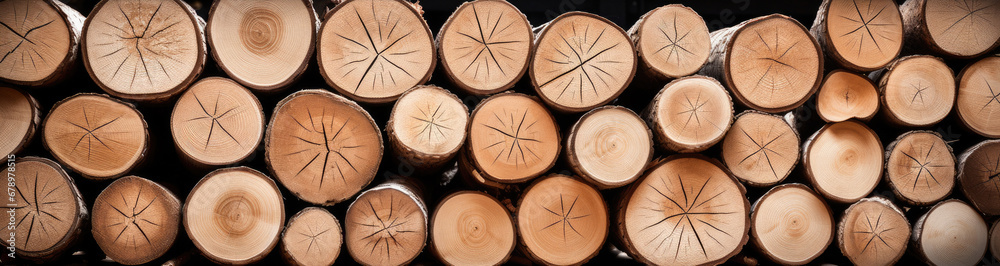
[80, 0, 207, 103]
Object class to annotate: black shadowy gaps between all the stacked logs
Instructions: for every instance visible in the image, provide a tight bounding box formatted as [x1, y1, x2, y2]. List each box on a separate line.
[3, 0, 997, 265]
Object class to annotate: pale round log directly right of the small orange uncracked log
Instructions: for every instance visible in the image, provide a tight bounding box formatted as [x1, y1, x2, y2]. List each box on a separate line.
[871, 55, 956, 127]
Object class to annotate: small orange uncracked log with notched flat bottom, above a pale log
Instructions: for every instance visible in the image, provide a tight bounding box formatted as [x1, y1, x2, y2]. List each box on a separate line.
[816, 69, 879, 122]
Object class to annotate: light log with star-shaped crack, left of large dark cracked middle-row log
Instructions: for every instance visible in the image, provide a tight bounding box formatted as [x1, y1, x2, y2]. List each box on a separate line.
[170, 77, 264, 168]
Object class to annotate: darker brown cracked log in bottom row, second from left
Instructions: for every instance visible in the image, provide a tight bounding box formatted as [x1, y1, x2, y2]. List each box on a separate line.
[91, 176, 181, 265]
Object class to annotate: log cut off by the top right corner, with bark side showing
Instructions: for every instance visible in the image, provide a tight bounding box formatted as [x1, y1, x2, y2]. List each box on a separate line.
[899, 0, 1000, 58]
